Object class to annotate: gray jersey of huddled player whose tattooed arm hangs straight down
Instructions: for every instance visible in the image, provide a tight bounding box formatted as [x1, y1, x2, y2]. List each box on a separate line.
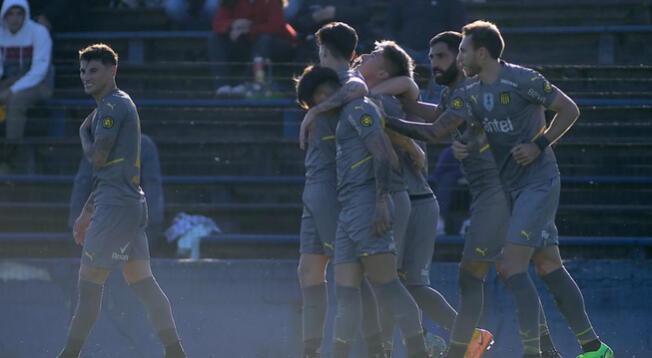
[335, 98, 383, 201]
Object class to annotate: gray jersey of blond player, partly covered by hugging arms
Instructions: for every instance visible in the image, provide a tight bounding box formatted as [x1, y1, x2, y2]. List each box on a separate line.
[374, 95, 432, 195]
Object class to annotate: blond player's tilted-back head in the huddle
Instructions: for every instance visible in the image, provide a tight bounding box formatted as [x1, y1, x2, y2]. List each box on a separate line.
[357, 41, 414, 86]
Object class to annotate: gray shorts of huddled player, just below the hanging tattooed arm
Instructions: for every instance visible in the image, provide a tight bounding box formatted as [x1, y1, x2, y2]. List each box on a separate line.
[334, 189, 396, 264]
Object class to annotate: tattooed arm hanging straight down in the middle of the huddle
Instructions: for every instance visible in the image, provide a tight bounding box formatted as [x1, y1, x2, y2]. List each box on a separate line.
[364, 130, 398, 236]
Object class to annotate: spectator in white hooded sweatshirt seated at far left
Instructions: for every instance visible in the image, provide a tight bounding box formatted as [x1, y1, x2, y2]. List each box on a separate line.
[0, 0, 53, 172]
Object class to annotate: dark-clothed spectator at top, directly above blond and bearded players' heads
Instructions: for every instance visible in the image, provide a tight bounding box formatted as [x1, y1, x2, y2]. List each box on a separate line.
[385, 0, 467, 63]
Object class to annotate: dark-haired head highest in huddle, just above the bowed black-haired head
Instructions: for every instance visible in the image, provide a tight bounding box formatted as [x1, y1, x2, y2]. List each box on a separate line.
[315, 22, 358, 66]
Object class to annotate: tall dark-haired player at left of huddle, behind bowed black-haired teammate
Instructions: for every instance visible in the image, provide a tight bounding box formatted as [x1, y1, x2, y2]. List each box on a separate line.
[297, 23, 390, 358]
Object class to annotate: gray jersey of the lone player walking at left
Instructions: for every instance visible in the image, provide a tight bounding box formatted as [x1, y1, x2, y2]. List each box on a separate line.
[91, 89, 145, 205]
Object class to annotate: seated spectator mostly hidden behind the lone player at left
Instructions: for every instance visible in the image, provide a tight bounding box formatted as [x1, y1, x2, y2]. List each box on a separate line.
[68, 134, 164, 251]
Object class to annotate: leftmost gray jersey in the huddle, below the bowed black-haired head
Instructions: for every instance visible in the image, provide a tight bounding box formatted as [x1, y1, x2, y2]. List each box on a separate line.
[305, 114, 338, 184]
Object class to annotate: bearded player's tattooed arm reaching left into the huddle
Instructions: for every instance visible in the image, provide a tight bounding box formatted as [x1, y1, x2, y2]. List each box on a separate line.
[386, 111, 464, 143]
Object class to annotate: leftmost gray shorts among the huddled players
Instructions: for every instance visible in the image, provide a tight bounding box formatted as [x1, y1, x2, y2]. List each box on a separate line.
[299, 182, 340, 256]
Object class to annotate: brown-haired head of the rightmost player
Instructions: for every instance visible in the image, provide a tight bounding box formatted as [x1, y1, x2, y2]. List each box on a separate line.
[458, 21, 505, 77]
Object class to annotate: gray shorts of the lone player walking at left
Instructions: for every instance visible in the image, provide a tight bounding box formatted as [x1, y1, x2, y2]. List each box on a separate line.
[82, 201, 149, 269]
